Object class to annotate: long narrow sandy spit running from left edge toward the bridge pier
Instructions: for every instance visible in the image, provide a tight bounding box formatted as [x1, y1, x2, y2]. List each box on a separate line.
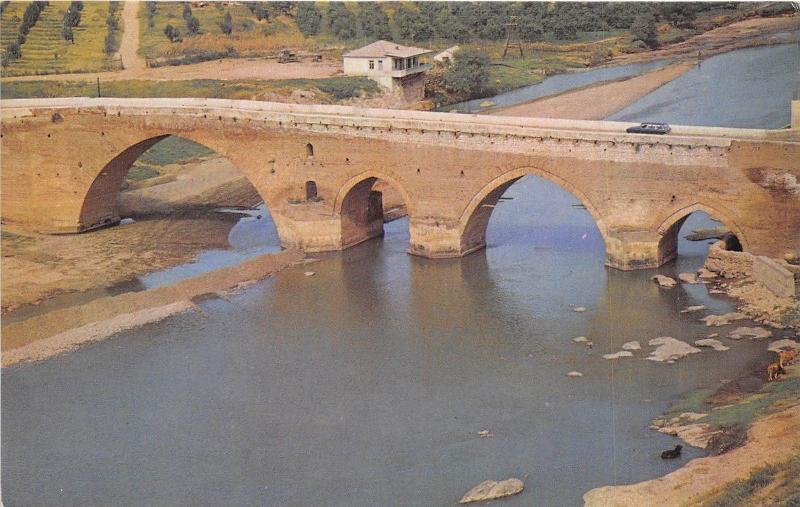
[2, 250, 304, 366]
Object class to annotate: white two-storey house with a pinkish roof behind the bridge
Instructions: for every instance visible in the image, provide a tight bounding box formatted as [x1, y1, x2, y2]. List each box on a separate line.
[342, 40, 432, 89]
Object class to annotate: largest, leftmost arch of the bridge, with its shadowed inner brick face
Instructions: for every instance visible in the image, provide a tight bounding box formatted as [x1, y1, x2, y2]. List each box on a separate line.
[78, 132, 284, 240]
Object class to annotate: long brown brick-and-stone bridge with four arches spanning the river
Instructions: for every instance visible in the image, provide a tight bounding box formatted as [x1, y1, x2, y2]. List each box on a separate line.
[0, 98, 800, 269]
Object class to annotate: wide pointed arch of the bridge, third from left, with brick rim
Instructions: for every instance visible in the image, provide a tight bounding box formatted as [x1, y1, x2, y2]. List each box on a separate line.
[459, 167, 608, 255]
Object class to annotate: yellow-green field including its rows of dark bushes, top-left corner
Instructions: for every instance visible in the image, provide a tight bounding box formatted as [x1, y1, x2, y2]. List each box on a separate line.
[0, 2, 122, 76]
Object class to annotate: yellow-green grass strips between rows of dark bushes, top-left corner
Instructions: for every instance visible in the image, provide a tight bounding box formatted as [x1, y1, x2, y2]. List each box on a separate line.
[2, 1, 119, 76]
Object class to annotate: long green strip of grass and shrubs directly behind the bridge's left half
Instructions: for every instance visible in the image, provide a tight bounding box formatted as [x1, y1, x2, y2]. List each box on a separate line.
[2, 77, 378, 103]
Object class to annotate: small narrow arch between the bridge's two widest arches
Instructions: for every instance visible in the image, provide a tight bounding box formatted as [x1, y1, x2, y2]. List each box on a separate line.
[333, 170, 414, 248]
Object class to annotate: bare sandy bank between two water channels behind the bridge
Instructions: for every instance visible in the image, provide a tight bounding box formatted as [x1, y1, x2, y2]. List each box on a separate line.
[489, 62, 694, 120]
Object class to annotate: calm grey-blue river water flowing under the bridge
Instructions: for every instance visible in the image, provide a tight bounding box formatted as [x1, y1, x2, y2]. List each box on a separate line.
[2, 45, 800, 506]
